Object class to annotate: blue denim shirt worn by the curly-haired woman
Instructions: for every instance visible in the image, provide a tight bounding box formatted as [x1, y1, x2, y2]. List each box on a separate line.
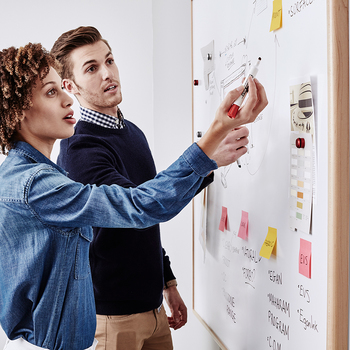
[0, 142, 217, 350]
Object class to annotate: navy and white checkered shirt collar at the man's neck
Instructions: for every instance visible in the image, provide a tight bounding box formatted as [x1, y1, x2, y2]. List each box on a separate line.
[80, 106, 125, 129]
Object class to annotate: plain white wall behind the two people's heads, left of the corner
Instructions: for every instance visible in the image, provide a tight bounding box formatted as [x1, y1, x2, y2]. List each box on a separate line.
[0, 0, 154, 161]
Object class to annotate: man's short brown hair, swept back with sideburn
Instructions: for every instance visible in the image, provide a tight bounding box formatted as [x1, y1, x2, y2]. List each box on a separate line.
[51, 26, 112, 79]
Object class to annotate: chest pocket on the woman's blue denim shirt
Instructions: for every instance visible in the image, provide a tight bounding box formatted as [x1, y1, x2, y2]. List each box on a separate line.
[74, 229, 92, 280]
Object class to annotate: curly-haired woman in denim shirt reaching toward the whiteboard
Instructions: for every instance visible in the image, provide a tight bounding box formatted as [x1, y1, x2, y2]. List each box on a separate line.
[0, 44, 267, 350]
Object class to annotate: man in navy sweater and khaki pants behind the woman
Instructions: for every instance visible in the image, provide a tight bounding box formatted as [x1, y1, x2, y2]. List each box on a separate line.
[51, 27, 254, 350]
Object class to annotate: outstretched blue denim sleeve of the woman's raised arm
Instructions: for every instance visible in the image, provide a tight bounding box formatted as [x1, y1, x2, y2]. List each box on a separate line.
[25, 144, 217, 228]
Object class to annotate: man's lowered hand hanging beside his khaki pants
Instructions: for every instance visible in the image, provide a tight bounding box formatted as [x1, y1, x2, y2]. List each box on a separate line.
[163, 286, 187, 330]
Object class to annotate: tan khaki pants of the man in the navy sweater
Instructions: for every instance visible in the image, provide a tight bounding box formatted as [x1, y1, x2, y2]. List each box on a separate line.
[95, 307, 173, 350]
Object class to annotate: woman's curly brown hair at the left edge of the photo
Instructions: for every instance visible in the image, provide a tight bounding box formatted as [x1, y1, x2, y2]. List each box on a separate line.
[0, 43, 61, 154]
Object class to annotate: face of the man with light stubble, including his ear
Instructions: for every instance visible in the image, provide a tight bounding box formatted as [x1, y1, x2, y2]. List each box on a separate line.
[63, 41, 122, 115]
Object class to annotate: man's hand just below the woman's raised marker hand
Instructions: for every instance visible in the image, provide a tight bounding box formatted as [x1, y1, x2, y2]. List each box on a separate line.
[212, 126, 249, 167]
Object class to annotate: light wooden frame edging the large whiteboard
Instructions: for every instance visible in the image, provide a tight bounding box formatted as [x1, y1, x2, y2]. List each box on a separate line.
[191, 0, 350, 350]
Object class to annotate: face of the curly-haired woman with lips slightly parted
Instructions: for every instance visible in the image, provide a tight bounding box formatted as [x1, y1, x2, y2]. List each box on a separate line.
[18, 68, 76, 156]
